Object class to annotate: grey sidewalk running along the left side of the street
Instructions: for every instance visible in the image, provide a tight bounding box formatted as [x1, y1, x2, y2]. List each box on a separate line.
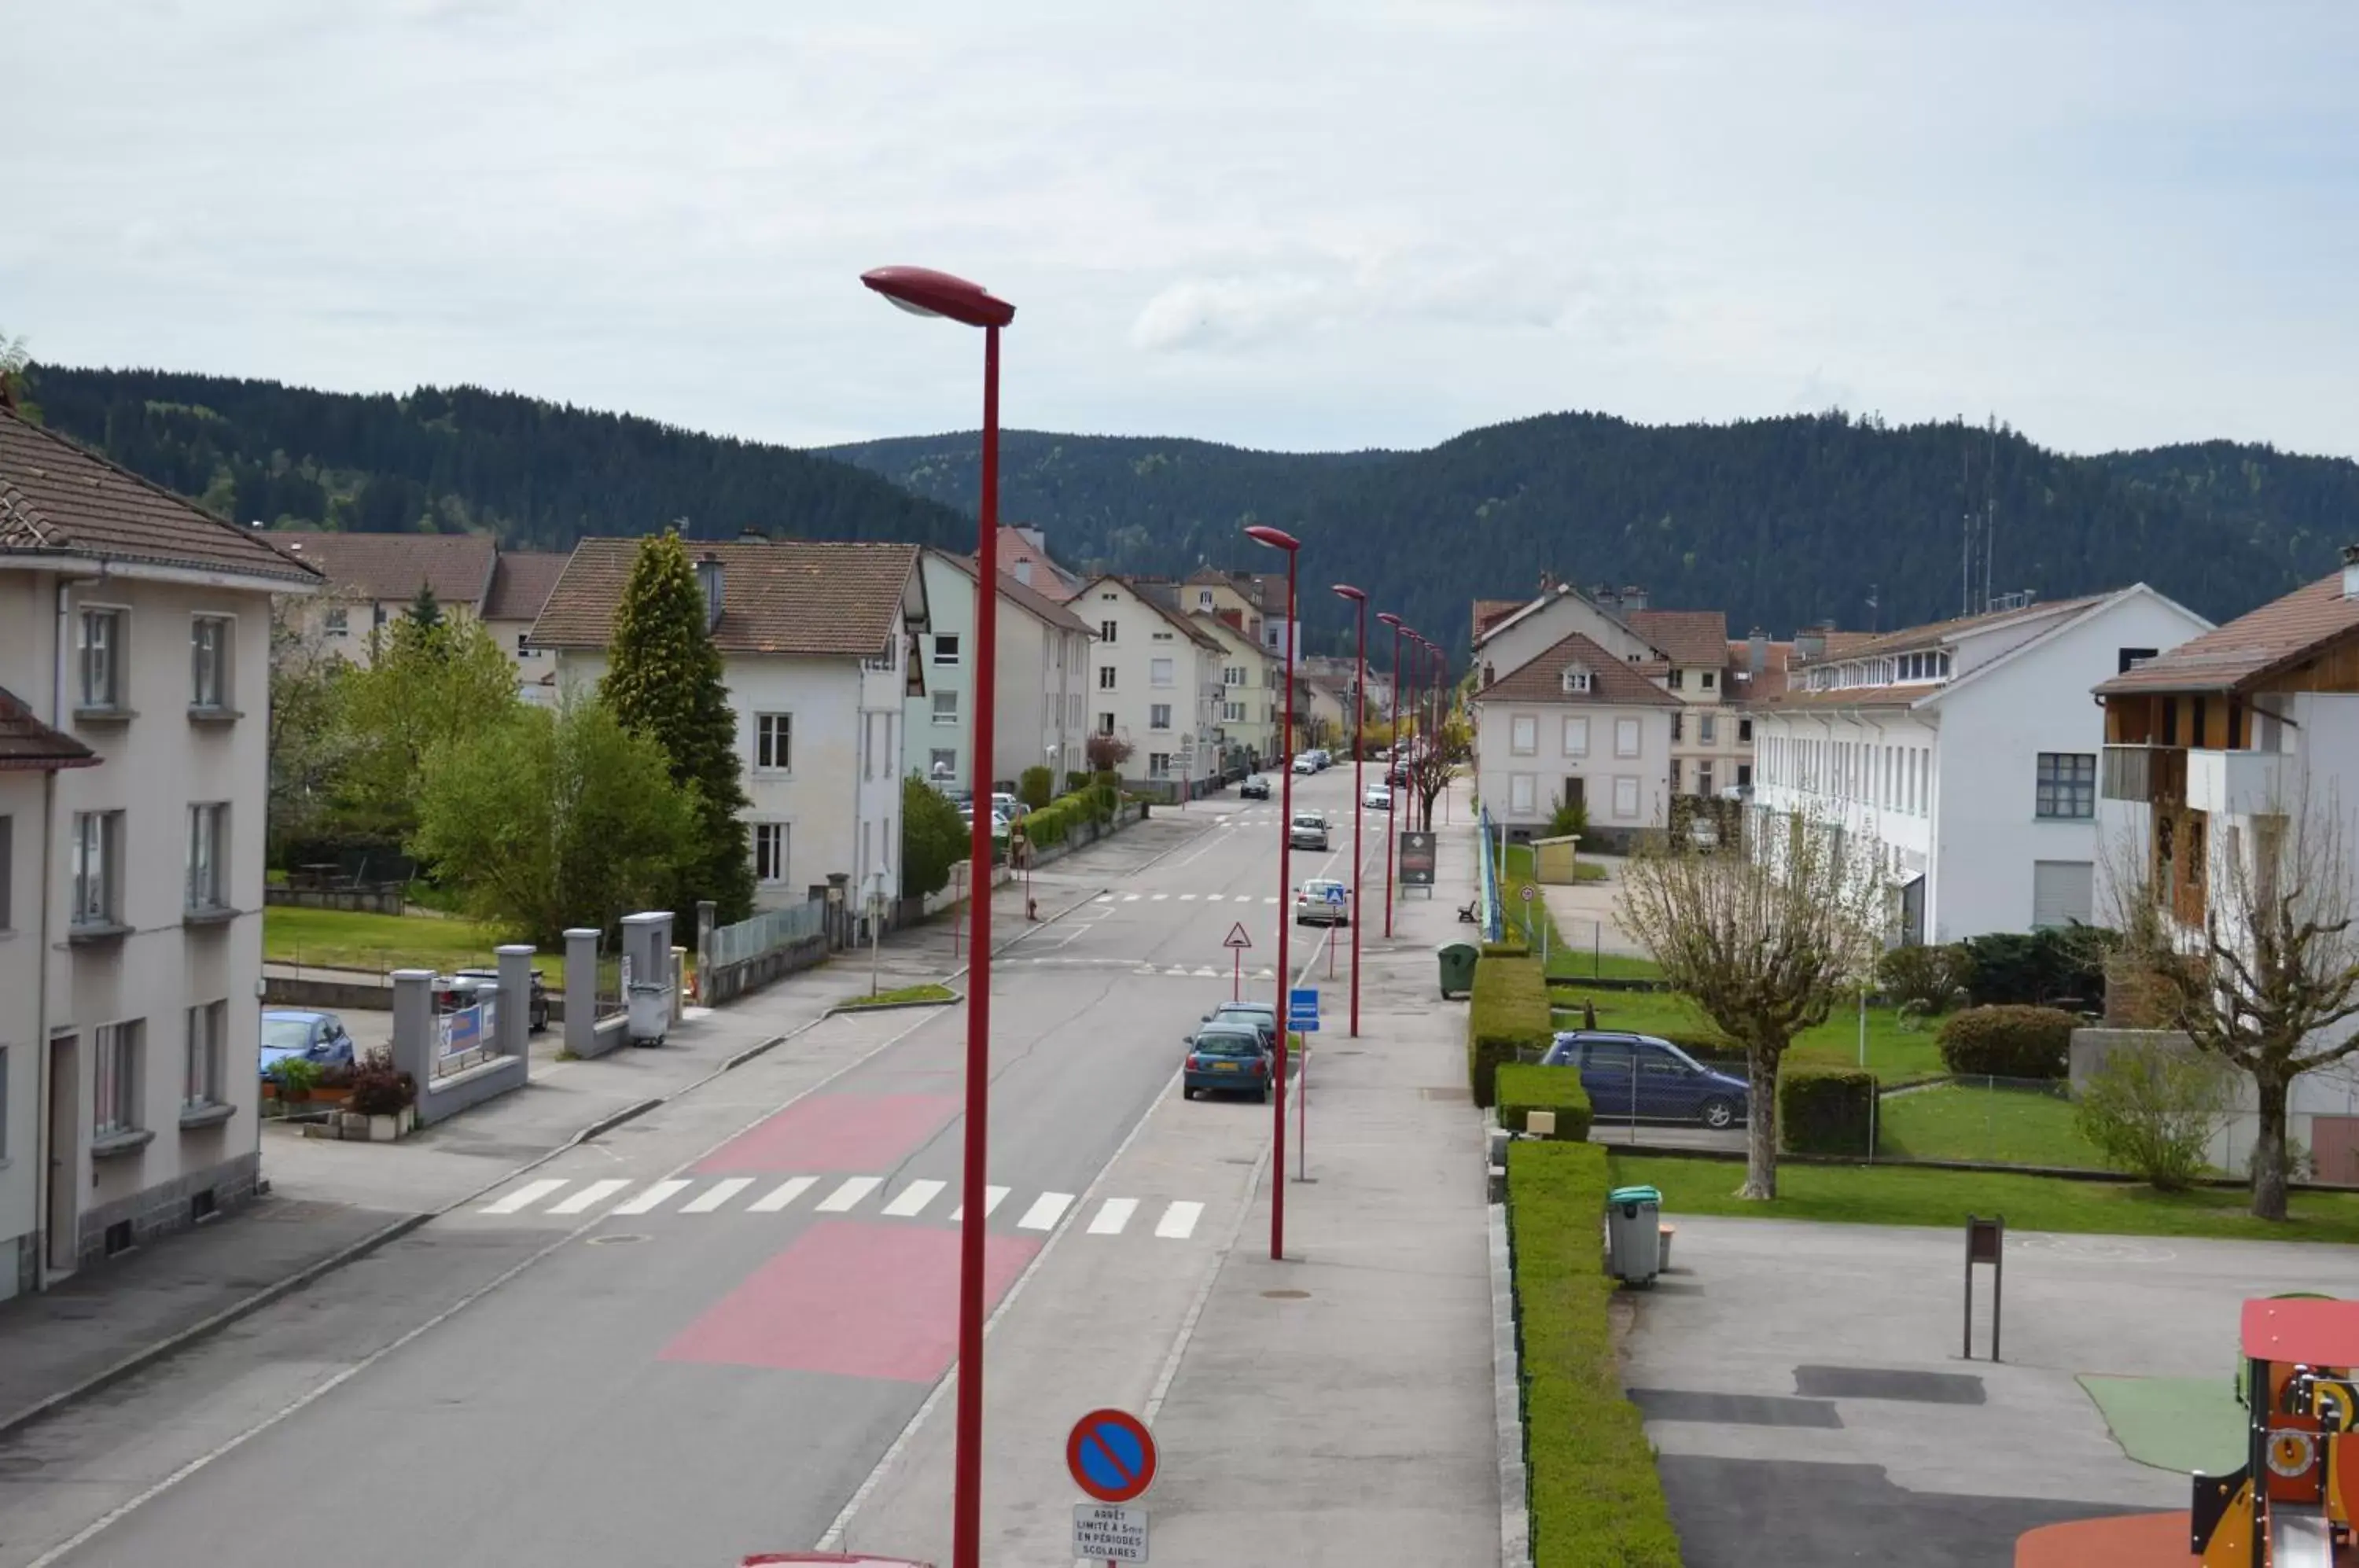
[0, 818, 1175, 1434]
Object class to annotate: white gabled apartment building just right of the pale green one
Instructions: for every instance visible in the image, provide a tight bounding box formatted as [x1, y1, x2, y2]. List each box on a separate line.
[1073, 578, 1227, 797]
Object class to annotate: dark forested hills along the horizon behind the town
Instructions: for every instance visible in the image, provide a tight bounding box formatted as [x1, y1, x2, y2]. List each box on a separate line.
[33, 366, 2359, 649]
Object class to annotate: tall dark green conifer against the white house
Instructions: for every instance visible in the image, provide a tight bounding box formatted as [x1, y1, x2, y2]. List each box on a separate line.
[599, 531, 753, 931]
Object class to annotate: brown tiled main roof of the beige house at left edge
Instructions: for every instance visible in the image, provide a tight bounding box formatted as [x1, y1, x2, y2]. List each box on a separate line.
[0, 406, 318, 587]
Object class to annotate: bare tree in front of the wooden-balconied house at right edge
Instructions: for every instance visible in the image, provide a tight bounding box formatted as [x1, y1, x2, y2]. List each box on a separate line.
[2107, 790, 2359, 1219]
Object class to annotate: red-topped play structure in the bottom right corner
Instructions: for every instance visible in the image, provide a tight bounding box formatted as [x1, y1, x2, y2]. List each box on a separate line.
[2189, 1297, 2359, 1568]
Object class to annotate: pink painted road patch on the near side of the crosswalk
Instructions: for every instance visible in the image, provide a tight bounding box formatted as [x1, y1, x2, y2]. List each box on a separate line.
[661, 1219, 1040, 1384]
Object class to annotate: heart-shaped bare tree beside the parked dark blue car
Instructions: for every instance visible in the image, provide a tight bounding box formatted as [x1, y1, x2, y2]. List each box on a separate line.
[1621, 815, 1890, 1198]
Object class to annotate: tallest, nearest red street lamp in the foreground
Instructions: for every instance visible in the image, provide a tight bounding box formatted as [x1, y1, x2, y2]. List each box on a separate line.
[861, 267, 1017, 1568]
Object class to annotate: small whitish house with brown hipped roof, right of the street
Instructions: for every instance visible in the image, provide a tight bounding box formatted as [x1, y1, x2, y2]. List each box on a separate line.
[1470, 632, 1682, 853]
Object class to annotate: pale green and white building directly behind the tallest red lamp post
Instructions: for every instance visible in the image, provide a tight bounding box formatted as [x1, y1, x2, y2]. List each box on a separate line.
[901, 550, 1090, 792]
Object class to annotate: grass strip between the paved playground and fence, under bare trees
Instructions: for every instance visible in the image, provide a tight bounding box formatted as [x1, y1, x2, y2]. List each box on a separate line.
[1614, 1155, 2359, 1245]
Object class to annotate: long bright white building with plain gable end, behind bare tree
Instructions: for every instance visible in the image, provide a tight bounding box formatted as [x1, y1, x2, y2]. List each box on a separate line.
[1753, 583, 2210, 940]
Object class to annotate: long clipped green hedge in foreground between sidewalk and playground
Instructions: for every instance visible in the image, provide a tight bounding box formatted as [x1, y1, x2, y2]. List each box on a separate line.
[1507, 1141, 1680, 1568]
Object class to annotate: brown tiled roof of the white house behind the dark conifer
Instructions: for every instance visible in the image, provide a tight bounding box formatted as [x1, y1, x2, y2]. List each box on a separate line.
[531, 540, 918, 658]
